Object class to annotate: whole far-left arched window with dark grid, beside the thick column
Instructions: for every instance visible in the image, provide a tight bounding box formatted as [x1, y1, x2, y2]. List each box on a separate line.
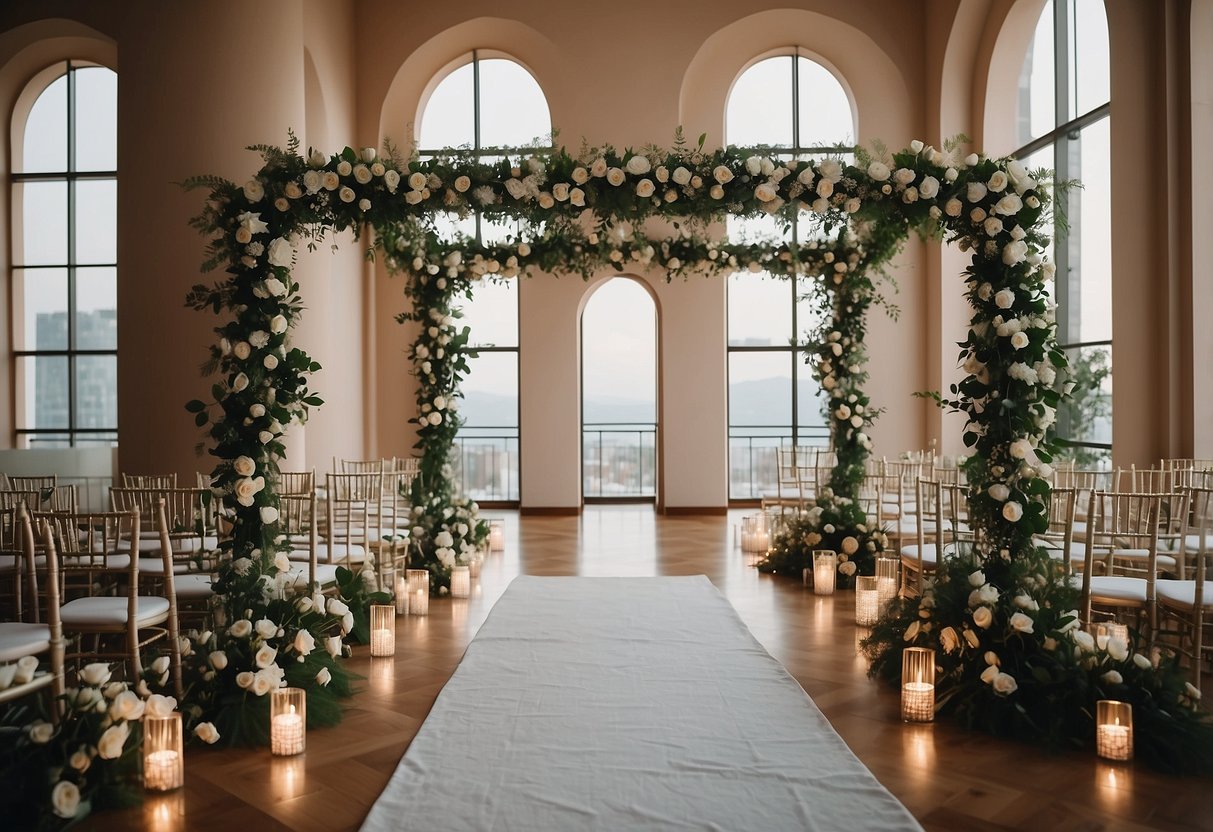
[11, 61, 118, 448]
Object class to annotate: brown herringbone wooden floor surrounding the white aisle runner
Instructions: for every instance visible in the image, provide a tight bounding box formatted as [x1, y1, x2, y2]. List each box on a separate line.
[92, 506, 1213, 832]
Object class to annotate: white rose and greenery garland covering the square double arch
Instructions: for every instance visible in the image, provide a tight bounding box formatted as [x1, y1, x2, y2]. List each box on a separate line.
[187, 138, 1208, 766]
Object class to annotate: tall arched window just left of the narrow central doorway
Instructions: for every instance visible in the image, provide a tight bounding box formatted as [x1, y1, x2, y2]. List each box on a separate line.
[417, 51, 552, 503]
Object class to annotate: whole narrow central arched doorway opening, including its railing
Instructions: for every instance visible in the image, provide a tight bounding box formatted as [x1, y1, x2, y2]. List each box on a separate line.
[581, 278, 659, 502]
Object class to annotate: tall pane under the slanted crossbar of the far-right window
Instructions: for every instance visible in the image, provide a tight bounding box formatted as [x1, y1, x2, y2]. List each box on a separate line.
[1077, 119, 1112, 343]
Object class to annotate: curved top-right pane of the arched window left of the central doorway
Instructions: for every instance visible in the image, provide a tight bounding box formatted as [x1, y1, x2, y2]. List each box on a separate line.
[480, 58, 552, 147]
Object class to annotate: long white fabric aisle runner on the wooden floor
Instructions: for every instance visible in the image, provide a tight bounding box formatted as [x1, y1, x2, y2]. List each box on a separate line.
[363, 576, 919, 832]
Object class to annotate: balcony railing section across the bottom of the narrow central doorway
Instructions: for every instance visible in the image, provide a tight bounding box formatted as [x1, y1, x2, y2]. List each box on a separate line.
[581, 422, 657, 498]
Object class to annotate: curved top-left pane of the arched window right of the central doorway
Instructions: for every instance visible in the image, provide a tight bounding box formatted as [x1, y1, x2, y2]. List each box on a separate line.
[724, 55, 792, 147]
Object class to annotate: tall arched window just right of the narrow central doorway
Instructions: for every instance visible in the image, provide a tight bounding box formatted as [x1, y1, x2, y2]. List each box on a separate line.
[724, 51, 856, 500]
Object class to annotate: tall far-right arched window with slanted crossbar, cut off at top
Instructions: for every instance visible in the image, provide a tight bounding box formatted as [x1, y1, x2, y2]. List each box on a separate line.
[1014, 0, 1112, 467]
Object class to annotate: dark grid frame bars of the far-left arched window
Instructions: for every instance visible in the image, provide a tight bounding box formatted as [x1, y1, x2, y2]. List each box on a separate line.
[8, 58, 119, 448]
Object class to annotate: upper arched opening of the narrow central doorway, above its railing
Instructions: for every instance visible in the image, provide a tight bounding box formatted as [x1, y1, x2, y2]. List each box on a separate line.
[581, 278, 657, 426]
